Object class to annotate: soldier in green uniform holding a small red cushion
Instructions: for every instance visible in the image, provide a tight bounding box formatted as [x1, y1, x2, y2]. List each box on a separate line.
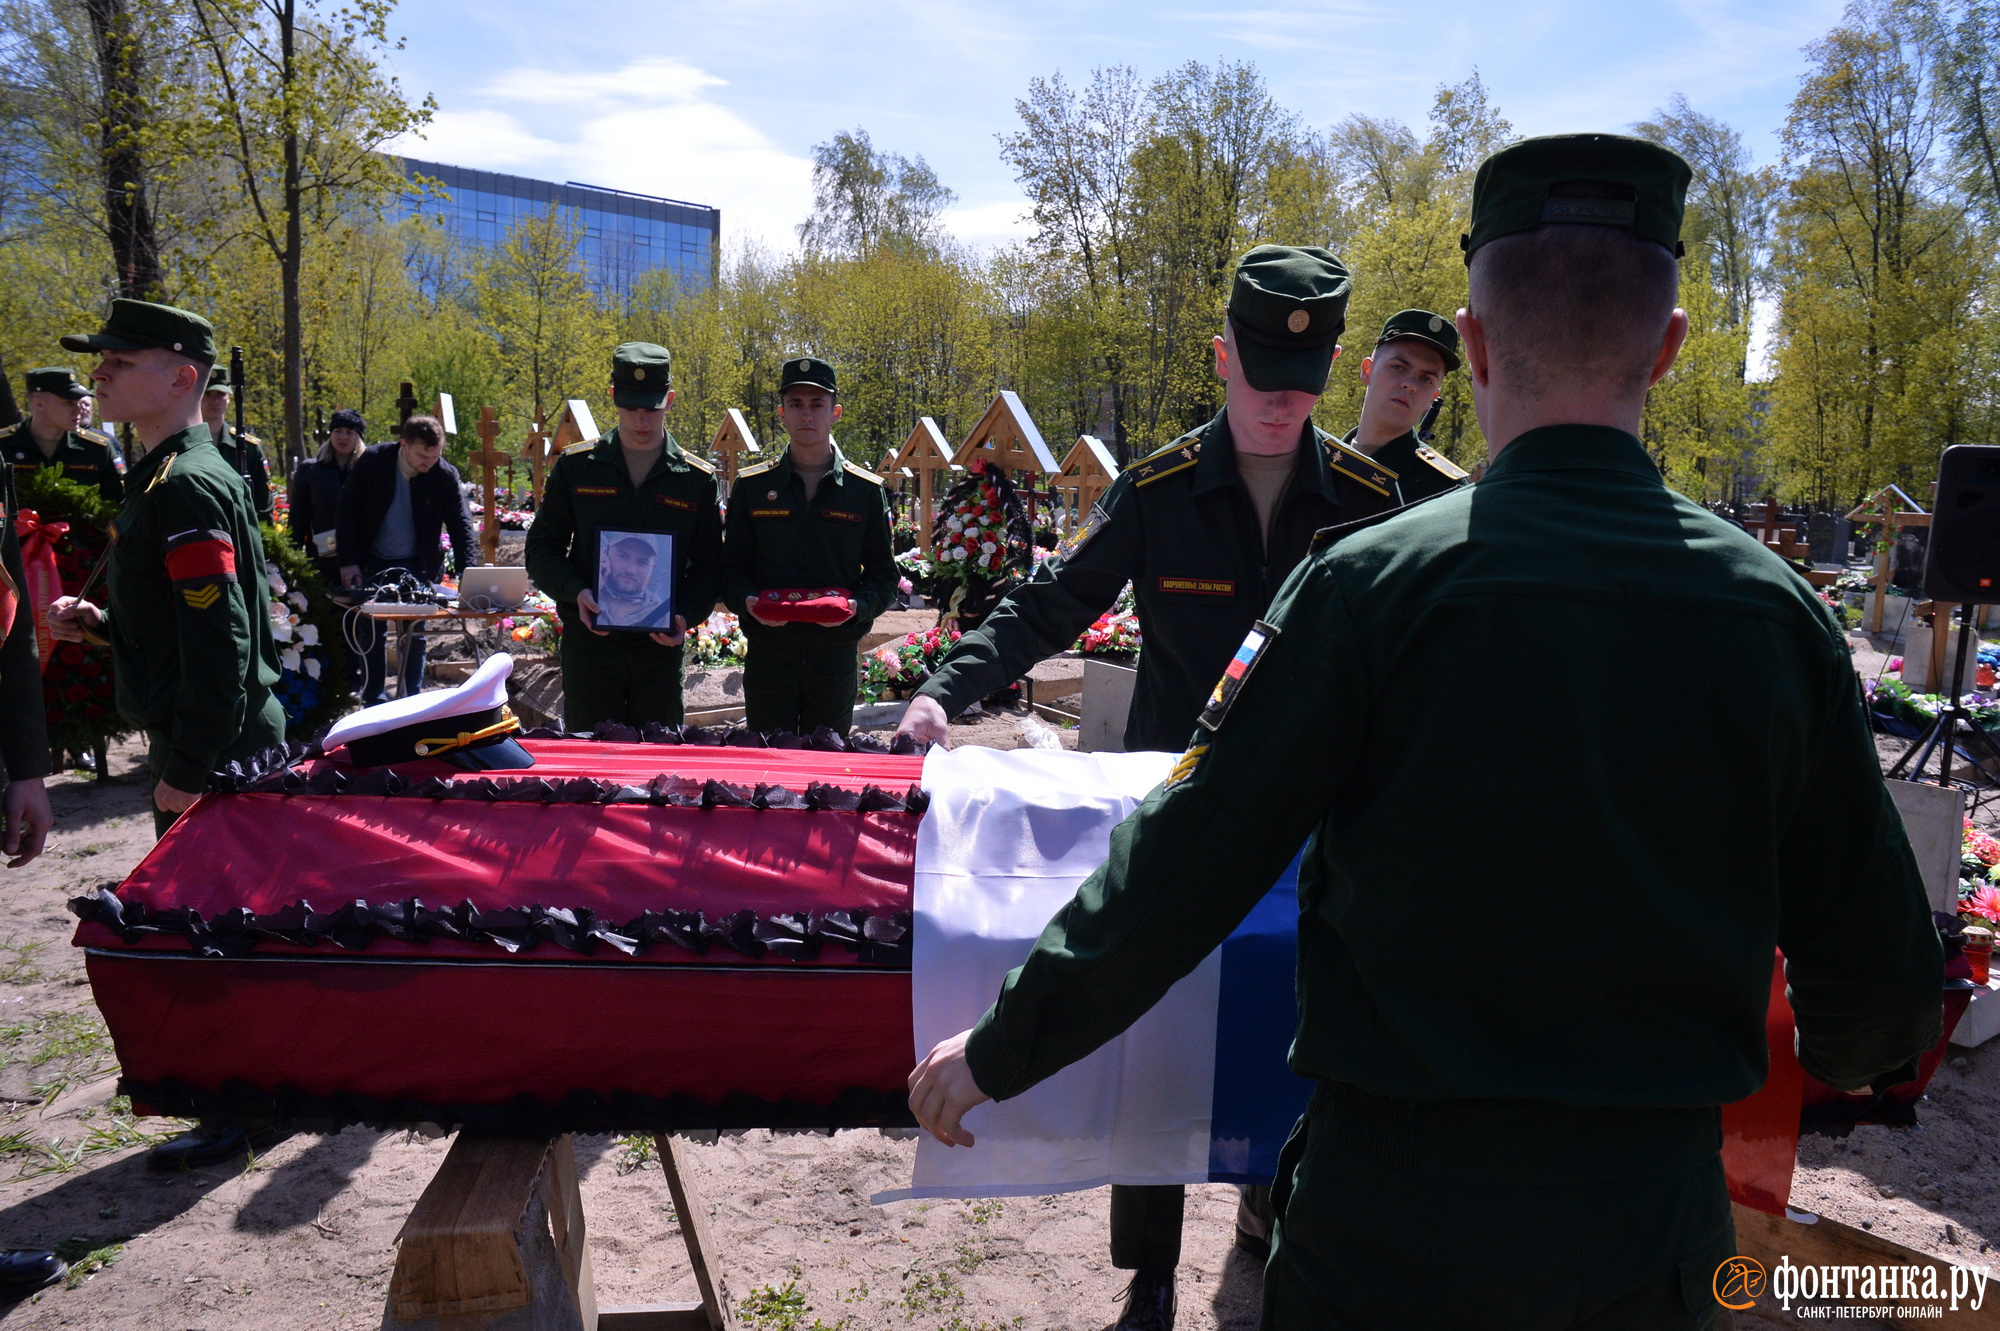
[722, 356, 896, 735]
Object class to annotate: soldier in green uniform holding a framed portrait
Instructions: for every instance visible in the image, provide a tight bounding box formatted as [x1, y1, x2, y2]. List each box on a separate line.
[528, 342, 722, 733]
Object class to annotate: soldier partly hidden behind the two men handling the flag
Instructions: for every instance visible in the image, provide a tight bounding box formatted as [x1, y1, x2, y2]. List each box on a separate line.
[1342, 310, 1466, 504]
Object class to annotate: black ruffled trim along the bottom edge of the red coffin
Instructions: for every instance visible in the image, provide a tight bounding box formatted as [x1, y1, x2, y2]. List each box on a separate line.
[118, 1077, 916, 1137]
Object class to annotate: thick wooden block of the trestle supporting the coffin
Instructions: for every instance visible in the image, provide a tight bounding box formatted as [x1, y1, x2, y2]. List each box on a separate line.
[390, 1133, 552, 1321]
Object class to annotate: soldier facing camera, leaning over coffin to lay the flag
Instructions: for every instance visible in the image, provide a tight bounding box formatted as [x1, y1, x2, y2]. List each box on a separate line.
[898, 246, 1398, 749]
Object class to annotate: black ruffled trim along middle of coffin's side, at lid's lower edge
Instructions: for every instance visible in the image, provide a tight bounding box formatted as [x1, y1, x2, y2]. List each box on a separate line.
[70, 885, 910, 971]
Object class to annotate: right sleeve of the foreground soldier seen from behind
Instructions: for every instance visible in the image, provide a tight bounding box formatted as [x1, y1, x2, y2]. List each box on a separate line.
[1778, 650, 1944, 1091]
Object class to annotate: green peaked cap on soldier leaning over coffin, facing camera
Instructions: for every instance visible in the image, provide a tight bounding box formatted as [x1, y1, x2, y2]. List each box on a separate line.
[1230, 246, 1354, 396]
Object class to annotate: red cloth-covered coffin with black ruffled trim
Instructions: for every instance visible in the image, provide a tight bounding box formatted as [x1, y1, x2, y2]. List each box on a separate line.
[72, 739, 922, 1131]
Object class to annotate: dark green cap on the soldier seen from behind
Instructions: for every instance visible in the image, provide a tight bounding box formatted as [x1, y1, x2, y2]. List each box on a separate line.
[1458, 134, 1692, 264]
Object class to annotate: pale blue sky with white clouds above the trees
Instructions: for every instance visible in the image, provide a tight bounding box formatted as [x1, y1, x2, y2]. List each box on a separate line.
[392, 0, 1842, 248]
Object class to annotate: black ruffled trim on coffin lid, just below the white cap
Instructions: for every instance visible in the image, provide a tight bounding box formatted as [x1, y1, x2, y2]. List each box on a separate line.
[208, 763, 930, 815]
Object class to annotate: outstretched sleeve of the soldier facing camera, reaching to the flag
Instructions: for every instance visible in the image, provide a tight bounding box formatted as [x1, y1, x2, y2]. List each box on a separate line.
[918, 478, 1146, 715]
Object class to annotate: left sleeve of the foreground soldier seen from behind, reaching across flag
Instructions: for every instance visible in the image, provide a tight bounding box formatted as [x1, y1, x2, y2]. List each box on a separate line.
[966, 560, 1372, 1099]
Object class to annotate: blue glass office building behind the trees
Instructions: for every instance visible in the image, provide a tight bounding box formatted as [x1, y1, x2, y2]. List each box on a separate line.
[402, 158, 722, 294]
